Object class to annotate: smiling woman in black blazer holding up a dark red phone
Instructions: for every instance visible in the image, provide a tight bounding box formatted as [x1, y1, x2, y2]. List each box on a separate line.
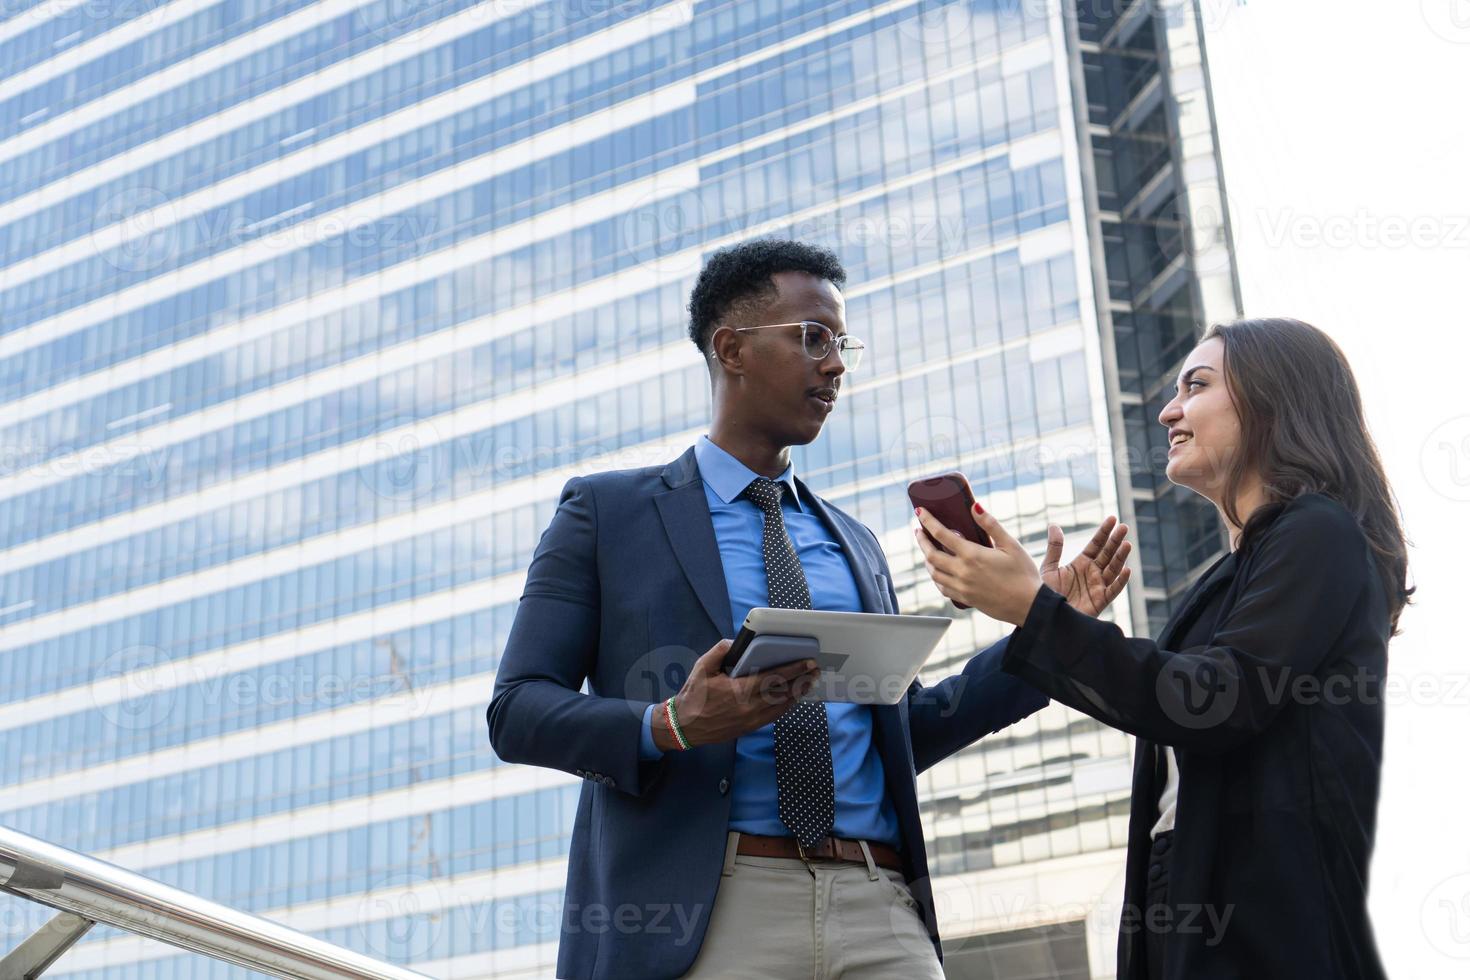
[916, 319, 1411, 980]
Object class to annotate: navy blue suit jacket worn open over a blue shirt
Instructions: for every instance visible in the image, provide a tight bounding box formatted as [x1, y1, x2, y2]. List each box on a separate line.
[487, 448, 1047, 980]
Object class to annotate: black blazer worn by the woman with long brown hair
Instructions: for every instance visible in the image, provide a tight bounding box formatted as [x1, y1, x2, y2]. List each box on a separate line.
[1004, 494, 1391, 980]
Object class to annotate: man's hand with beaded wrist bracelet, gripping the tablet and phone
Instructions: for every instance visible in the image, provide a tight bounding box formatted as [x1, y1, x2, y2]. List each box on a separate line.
[653, 639, 822, 752]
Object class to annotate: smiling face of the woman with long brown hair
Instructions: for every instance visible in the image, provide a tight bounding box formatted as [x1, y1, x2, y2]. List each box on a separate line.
[1158, 338, 1241, 502]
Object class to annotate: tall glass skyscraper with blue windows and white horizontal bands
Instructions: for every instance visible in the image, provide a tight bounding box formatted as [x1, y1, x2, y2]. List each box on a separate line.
[0, 0, 1238, 980]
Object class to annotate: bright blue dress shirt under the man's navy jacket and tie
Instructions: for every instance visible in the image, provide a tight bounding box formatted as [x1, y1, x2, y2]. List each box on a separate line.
[639, 436, 900, 846]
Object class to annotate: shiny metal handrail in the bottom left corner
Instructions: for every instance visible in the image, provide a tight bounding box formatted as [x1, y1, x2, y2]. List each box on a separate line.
[0, 827, 426, 980]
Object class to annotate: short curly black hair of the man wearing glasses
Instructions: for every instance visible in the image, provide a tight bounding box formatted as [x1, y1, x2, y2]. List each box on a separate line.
[689, 238, 847, 354]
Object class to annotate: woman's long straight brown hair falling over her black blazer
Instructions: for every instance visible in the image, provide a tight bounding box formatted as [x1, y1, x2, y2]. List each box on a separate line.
[1204, 317, 1414, 633]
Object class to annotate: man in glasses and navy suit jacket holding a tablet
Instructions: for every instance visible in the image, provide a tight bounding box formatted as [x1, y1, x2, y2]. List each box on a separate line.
[488, 239, 1105, 980]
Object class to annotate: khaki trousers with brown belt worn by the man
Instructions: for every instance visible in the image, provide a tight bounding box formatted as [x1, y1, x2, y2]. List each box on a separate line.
[685, 830, 944, 980]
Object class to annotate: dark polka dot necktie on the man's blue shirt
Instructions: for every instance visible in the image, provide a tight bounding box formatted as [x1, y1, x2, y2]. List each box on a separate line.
[741, 476, 833, 845]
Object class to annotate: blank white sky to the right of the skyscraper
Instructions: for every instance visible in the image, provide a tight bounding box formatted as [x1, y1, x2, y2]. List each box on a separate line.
[1199, 0, 1470, 980]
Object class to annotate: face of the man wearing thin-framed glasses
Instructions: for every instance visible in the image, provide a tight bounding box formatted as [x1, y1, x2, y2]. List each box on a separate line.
[714, 272, 847, 447]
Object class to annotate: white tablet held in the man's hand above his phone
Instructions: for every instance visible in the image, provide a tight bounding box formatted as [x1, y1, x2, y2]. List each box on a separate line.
[725, 607, 954, 704]
